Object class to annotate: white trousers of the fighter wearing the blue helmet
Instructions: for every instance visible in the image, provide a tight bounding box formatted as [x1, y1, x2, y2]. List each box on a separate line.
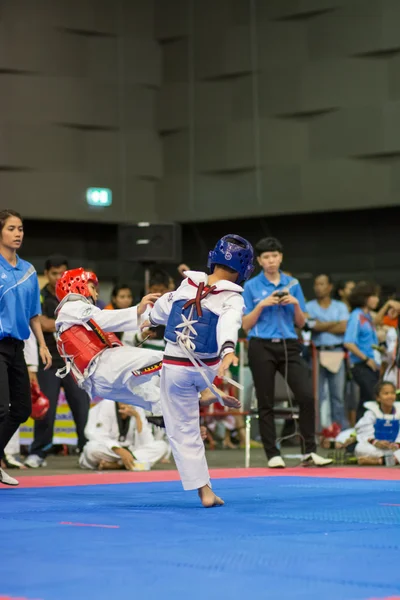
[161, 364, 218, 490]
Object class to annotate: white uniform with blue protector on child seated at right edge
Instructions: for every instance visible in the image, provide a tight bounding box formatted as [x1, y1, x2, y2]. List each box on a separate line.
[354, 401, 400, 462]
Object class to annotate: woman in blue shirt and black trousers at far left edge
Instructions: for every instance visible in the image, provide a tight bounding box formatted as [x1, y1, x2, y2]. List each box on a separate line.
[0, 210, 51, 485]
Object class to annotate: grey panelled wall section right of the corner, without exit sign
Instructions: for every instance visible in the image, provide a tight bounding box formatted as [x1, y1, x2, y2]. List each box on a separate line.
[156, 0, 400, 221]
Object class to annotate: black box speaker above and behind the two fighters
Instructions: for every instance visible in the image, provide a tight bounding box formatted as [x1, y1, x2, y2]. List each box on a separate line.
[118, 223, 182, 264]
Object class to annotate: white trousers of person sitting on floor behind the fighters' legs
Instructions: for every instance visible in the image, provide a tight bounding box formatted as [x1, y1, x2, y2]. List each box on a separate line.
[79, 440, 170, 469]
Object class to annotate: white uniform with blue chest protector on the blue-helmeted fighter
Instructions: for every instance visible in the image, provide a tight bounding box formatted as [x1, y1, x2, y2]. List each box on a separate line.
[149, 271, 244, 490]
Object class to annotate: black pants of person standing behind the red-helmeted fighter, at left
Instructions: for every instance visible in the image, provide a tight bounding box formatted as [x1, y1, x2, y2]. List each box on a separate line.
[30, 368, 90, 458]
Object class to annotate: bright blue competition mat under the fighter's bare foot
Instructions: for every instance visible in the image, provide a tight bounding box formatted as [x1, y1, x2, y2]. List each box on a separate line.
[0, 477, 400, 600]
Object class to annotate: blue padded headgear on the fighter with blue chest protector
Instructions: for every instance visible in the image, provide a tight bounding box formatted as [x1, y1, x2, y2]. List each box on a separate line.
[207, 234, 254, 285]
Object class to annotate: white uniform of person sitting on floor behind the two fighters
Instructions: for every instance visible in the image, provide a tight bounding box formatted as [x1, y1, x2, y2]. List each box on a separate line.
[79, 400, 170, 469]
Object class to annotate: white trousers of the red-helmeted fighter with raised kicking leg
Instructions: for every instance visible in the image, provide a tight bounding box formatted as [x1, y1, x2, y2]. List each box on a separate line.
[89, 346, 163, 415]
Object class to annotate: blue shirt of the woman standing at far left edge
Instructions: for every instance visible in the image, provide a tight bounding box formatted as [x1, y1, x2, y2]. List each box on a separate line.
[0, 254, 42, 340]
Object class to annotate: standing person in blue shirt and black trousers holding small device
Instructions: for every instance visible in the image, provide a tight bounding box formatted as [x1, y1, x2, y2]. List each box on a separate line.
[243, 237, 332, 468]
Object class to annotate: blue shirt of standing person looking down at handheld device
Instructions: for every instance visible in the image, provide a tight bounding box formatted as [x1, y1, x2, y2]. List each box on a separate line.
[243, 271, 306, 339]
